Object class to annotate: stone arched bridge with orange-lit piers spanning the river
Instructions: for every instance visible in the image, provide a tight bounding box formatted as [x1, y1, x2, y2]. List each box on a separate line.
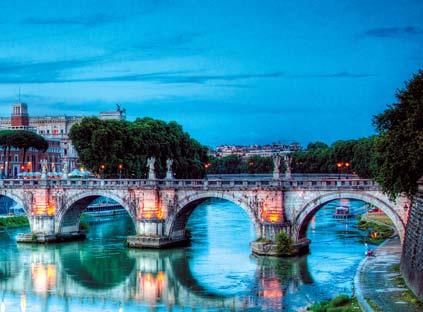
[0, 175, 410, 255]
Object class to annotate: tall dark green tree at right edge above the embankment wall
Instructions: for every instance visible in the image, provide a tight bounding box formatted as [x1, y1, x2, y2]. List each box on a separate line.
[373, 70, 423, 198]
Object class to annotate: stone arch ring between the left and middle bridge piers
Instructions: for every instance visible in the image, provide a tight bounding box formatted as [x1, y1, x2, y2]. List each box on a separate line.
[56, 190, 136, 233]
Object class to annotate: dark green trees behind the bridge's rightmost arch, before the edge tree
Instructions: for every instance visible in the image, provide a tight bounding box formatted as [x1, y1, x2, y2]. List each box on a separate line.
[292, 137, 376, 178]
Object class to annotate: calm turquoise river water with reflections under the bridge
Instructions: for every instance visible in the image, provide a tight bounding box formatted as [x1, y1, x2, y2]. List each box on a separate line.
[0, 200, 372, 312]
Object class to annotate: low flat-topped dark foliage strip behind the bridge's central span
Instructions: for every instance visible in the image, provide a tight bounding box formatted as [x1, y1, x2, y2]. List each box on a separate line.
[208, 155, 284, 174]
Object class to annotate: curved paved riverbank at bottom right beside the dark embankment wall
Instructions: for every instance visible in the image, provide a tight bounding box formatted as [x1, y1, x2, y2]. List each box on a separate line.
[356, 237, 423, 312]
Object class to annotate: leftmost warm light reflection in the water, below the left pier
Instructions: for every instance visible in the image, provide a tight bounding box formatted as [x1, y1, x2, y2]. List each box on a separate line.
[31, 263, 56, 293]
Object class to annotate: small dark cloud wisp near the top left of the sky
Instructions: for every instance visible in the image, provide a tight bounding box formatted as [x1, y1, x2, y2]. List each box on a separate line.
[23, 14, 115, 27]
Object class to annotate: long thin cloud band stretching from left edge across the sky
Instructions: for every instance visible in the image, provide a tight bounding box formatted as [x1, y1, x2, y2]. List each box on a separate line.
[0, 54, 375, 88]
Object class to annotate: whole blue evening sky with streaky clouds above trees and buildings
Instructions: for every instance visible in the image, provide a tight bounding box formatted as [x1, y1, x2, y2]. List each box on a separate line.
[0, 0, 423, 146]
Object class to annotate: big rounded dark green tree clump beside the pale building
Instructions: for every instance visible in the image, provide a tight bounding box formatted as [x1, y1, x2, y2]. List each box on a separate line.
[69, 118, 208, 178]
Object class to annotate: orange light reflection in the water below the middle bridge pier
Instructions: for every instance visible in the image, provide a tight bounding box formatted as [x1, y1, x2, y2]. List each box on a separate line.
[136, 272, 167, 303]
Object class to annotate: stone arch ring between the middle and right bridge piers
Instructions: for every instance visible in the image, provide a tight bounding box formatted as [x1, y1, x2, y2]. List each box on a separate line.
[166, 191, 261, 237]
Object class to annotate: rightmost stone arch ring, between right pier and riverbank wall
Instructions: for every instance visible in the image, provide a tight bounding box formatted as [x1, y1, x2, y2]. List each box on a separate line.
[294, 191, 405, 241]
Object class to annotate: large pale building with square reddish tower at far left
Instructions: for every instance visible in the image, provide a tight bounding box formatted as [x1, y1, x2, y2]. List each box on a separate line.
[0, 103, 125, 177]
